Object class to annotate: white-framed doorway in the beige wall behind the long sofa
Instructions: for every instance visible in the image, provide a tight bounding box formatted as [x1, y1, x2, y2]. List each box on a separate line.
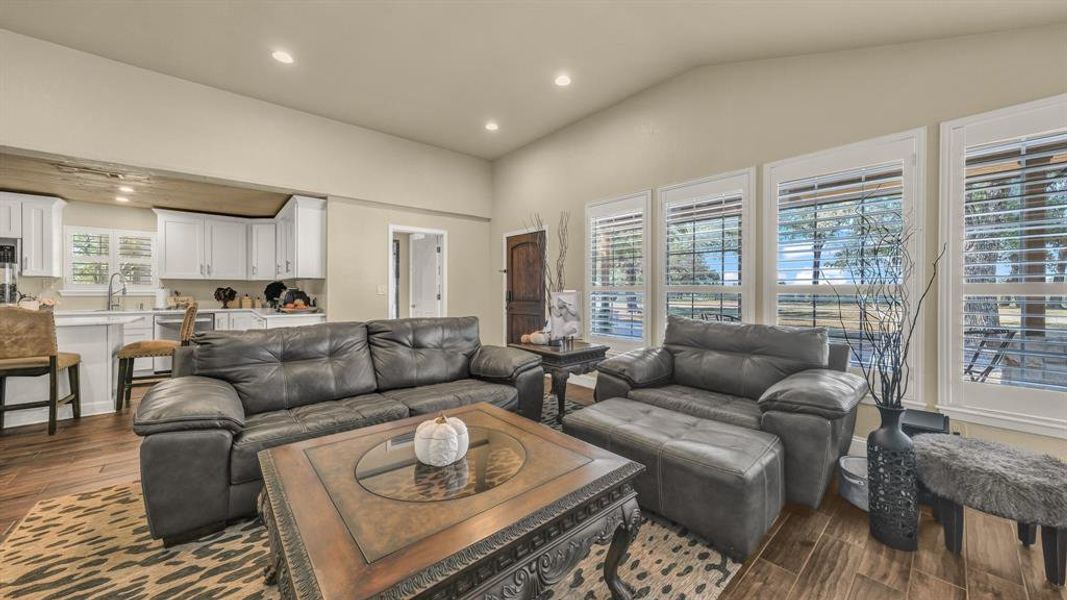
[388, 224, 447, 318]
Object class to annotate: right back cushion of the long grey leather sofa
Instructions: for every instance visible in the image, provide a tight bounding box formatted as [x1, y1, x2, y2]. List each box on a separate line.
[367, 317, 481, 391]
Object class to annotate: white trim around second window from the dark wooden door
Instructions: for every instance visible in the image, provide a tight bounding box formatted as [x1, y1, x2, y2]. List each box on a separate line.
[653, 167, 758, 342]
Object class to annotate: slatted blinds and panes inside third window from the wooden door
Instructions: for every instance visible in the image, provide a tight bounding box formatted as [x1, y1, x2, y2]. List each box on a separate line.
[777, 161, 904, 364]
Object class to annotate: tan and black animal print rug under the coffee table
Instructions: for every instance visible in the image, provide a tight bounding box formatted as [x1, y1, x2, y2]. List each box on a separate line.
[0, 399, 740, 600]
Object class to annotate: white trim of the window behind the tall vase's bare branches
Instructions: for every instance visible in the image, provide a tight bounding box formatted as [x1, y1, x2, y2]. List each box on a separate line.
[762, 127, 930, 408]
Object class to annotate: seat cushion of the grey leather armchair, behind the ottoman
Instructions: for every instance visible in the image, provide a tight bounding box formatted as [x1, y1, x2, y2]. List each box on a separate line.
[630, 384, 761, 429]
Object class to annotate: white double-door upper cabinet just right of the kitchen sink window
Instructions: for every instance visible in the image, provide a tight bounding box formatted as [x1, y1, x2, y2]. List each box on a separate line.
[156, 210, 249, 279]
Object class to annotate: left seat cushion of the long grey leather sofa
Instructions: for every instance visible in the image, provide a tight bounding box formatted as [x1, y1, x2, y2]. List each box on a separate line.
[229, 394, 408, 484]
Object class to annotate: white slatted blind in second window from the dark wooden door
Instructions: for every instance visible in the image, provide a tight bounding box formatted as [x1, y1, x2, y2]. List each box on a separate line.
[658, 170, 754, 321]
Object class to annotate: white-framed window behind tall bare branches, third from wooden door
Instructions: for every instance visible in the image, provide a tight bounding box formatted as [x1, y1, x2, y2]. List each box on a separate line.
[764, 129, 925, 401]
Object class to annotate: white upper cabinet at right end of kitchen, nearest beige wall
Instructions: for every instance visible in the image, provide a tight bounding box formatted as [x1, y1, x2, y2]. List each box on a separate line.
[274, 195, 327, 279]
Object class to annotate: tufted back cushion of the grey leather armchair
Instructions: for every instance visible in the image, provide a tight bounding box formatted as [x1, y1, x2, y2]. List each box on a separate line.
[664, 316, 829, 399]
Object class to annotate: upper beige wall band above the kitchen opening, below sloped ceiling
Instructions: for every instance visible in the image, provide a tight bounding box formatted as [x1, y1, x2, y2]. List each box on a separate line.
[0, 30, 491, 217]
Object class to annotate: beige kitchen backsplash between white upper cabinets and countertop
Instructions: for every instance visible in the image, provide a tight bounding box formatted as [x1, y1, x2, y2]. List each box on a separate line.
[18, 278, 325, 311]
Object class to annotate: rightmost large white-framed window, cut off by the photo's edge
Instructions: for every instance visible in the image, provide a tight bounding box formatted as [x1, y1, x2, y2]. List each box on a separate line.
[939, 95, 1067, 438]
